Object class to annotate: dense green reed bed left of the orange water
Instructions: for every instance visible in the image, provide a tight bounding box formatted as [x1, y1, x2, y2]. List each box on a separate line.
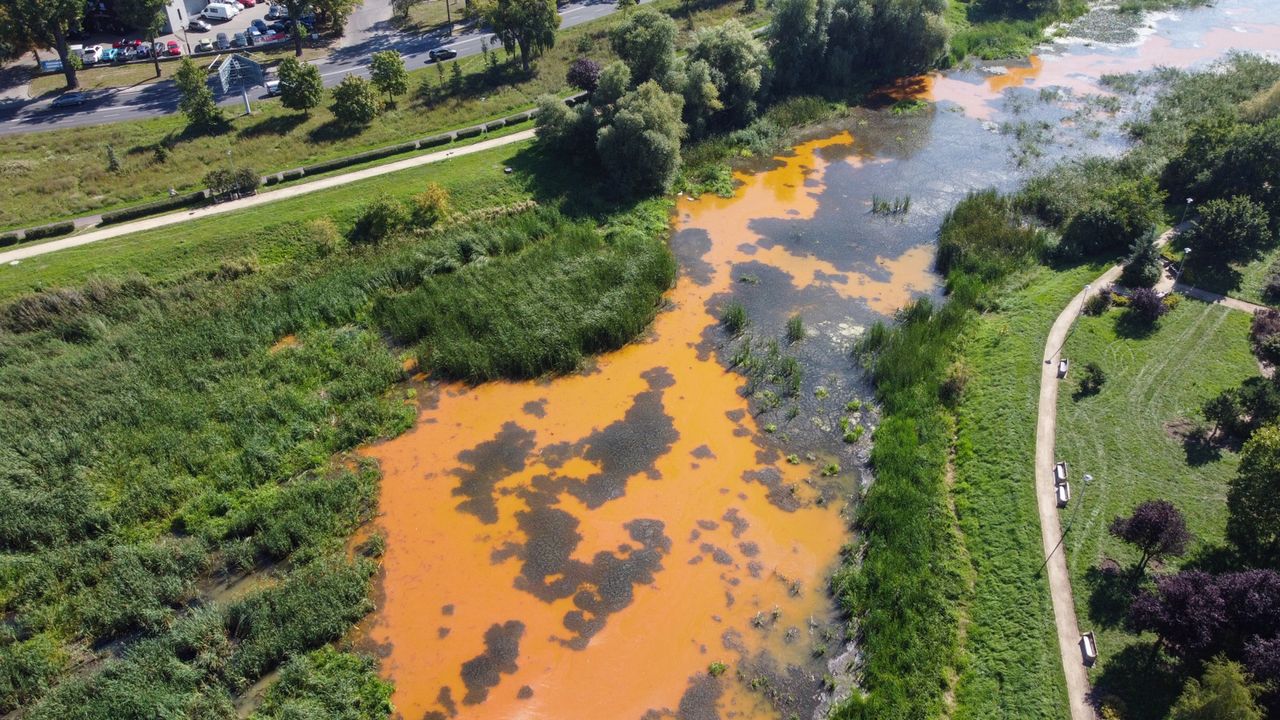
[0, 139, 673, 719]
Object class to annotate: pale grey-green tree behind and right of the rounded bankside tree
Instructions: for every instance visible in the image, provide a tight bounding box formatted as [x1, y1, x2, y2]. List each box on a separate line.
[689, 20, 768, 127]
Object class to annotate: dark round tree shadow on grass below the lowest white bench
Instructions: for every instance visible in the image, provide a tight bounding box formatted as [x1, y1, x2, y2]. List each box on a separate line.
[1091, 641, 1183, 720]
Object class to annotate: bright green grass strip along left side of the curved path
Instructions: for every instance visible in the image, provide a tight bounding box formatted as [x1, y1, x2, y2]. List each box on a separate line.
[955, 266, 1101, 719]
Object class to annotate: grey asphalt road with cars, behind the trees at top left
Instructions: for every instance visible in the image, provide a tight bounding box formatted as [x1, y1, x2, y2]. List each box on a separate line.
[0, 0, 646, 135]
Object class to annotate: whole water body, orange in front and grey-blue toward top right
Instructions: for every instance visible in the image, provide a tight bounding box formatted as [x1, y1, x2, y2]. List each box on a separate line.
[360, 0, 1280, 720]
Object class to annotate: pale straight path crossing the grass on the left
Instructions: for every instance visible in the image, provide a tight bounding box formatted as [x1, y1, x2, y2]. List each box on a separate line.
[0, 128, 534, 265]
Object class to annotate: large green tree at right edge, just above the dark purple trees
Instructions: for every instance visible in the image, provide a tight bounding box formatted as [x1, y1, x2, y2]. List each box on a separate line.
[1226, 425, 1280, 566]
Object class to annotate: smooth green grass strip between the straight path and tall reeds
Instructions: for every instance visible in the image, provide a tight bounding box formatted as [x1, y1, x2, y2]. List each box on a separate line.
[0, 133, 535, 302]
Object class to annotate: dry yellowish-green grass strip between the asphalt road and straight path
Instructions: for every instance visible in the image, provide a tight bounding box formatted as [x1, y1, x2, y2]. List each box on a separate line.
[0, 0, 767, 228]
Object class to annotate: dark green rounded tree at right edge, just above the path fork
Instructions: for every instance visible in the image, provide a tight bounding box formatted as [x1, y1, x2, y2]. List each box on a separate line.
[1185, 195, 1274, 265]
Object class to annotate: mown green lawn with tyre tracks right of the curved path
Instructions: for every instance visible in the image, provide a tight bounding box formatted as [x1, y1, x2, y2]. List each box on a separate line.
[1057, 300, 1258, 720]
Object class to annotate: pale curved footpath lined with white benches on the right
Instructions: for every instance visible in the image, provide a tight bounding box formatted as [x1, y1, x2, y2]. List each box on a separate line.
[1036, 266, 1120, 720]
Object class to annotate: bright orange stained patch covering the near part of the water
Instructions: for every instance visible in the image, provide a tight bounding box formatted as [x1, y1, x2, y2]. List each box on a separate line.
[362, 133, 933, 720]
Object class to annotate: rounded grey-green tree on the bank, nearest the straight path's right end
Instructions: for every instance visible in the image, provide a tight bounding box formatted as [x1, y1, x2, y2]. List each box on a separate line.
[596, 81, 685, 193]
